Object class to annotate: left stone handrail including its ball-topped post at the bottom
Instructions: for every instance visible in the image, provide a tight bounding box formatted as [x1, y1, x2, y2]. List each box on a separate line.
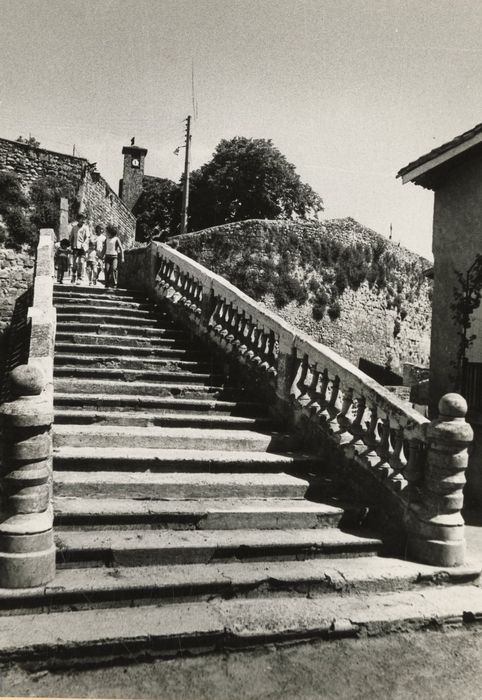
[0, 229, 55, 588]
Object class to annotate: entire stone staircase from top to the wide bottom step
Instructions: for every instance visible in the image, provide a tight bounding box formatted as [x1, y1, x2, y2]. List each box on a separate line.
[0, 286, 480, 658]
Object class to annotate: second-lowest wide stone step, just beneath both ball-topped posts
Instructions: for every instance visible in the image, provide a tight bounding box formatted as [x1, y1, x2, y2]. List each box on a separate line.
[0, 556, 480, 616]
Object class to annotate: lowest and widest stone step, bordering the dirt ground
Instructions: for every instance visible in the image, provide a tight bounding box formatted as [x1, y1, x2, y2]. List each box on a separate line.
[0, 584, 482, 668]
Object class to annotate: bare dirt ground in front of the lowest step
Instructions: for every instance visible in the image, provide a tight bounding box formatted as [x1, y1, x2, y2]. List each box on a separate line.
[0, 628, 482, 700]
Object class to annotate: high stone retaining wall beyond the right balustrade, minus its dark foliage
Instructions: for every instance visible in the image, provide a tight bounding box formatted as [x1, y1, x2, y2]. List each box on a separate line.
[172, 218, 432, 374]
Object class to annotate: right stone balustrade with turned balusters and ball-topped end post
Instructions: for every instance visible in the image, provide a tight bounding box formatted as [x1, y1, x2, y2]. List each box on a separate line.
[123, 243, 472, 566]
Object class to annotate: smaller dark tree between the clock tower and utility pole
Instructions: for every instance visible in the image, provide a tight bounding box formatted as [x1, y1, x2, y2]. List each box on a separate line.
[132, 178, 180, 241]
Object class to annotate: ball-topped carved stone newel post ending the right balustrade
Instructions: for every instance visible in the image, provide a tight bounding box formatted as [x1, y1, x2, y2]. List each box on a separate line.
[408, 394, 474, 566]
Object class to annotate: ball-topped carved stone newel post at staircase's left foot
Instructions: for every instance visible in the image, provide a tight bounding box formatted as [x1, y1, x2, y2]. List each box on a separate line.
[0, 365, 55, 588]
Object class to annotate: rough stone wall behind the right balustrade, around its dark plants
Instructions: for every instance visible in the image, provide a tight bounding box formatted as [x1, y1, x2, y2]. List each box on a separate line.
[173, 219, 431, 374]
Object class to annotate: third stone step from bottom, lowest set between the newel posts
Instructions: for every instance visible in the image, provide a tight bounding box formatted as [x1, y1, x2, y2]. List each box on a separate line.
[55, 528, 382, 568]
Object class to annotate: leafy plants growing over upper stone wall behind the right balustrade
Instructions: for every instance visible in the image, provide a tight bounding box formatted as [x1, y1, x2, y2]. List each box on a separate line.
[176, 219, 425, 322]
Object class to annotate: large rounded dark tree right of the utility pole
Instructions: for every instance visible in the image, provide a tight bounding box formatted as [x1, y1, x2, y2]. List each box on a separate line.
[189, 136, 323, 231]
